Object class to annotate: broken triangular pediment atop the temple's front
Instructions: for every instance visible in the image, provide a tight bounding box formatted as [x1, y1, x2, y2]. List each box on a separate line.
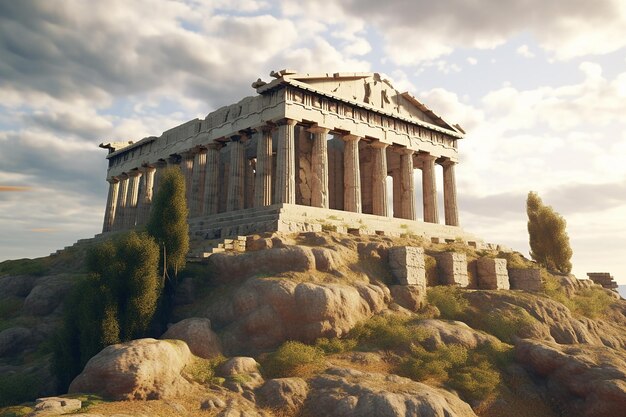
[257, 70, 463, 133]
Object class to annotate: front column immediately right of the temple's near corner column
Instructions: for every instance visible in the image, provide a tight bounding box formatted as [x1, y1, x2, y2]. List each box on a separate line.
[309, 126, 330, 208]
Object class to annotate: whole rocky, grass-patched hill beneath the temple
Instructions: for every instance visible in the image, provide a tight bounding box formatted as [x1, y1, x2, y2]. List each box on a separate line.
[0, 233, 626, 417]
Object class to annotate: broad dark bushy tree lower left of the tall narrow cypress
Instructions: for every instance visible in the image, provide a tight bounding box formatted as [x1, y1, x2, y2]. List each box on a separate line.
[54, 232, 161, 389]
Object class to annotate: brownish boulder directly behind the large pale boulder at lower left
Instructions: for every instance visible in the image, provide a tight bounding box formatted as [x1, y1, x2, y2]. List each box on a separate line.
[160, 317, 222, 359]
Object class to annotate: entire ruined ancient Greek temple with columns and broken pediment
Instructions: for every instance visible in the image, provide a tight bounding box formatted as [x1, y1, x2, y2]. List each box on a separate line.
[100, 70, 472, 244]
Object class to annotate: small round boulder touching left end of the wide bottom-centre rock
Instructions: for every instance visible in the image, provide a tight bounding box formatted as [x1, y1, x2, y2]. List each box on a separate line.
[257, 378, 309, 414]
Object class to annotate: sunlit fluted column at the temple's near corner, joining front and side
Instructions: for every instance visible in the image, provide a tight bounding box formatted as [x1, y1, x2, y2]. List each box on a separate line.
[274, 119, 297, 204]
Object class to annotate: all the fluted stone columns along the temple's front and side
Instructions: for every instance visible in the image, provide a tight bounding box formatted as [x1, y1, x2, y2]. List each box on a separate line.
[103, 119, 459, 231]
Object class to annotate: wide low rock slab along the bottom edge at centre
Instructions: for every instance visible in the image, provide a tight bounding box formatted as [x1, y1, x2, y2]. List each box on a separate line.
[305, 368, 476, 417]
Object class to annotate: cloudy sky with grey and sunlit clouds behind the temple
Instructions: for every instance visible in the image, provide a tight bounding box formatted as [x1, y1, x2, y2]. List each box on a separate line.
[0, 0, 626, 284]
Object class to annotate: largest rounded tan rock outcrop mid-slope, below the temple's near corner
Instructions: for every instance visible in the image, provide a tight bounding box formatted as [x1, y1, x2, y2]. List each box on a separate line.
[205, 278, 390, 354]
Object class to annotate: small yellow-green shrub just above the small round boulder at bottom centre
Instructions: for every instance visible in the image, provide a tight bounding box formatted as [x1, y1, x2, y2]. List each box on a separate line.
[262, 341, 324, 378]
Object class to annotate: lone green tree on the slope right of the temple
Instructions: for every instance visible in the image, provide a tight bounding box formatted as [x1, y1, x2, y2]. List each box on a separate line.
[526, 191, 572, 274]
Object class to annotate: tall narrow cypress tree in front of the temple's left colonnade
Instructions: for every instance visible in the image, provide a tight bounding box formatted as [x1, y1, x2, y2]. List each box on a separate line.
[147, 167, 189, 277]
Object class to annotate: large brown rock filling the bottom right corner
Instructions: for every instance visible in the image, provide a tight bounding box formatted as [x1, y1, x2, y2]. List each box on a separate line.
[515, 340, 626, 417]
